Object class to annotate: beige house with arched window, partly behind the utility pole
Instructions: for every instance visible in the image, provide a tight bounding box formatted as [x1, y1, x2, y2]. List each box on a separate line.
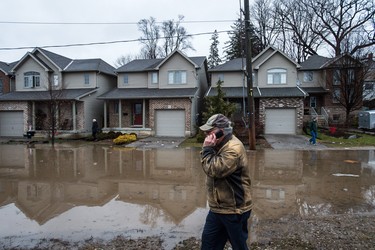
[207, 47, 308, 134]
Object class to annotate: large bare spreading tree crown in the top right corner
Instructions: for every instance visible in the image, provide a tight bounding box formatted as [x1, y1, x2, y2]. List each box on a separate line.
[302, 0, 375, 56]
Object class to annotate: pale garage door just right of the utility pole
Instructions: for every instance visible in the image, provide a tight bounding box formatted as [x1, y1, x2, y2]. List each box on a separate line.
[265, 109, 296, 134]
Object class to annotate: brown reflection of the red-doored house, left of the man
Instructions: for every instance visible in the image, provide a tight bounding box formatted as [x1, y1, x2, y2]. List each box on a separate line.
[108, 149, 206, 224]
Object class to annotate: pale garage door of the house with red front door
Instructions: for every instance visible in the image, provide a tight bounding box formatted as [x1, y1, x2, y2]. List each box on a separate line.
[155, 110, 185, 137]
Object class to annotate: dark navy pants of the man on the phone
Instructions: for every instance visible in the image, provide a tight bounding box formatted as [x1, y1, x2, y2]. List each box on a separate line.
[201, 211, 251, 250]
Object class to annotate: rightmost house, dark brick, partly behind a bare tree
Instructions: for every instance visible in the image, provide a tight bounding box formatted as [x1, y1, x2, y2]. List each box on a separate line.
[298, 55, 362, 126]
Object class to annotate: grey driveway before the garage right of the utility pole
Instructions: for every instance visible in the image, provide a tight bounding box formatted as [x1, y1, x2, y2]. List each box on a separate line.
[264, 135, 327, 150]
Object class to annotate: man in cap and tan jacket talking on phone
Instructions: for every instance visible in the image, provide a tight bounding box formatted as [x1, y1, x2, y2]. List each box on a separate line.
[200, 114, 252, 250]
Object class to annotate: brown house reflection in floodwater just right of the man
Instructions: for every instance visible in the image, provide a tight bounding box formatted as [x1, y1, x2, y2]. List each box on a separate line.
[251, 150, 303, 219]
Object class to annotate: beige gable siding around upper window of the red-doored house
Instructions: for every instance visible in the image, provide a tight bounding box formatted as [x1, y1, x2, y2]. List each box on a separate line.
[159, 53, 198, 89]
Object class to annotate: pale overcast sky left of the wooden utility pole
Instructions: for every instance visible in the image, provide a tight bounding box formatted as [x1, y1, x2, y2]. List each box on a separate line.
[0, 0, 252, 65]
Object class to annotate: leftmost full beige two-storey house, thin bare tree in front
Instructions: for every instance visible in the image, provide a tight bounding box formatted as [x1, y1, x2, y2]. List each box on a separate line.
[0, 48, 116, 136]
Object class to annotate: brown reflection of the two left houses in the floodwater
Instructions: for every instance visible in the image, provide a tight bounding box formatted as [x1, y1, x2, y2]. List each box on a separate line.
[0, 144, 206, 224]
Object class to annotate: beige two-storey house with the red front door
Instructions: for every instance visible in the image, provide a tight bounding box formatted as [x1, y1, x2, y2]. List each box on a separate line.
[98, 50, 208, 137]
